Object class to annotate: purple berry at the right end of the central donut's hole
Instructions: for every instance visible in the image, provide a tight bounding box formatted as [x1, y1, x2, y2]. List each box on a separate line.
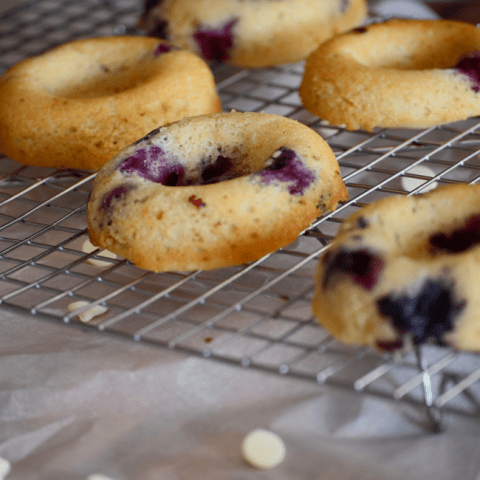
[258, 147, 315, 195]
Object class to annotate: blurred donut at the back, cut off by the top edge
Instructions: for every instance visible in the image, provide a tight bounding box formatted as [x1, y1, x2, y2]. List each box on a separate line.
[139, 0, 367, 67]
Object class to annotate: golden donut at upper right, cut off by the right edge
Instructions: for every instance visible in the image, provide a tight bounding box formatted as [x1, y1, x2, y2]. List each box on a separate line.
[299, 20, 480, 131]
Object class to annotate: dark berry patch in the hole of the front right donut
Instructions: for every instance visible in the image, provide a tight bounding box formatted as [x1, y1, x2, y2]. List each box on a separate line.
[430, 215, 480, 253]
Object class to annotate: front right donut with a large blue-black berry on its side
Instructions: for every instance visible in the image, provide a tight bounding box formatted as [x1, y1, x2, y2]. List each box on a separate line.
[313, 184, 480, 350]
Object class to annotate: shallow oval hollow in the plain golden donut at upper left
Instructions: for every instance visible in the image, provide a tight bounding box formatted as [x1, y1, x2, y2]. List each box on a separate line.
[38, 43, 165, 98]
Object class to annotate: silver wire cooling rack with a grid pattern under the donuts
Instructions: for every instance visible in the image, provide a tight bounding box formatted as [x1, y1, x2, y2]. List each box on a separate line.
[0, 0, 480, 428]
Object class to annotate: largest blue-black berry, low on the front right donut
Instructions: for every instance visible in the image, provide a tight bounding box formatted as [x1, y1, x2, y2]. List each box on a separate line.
[377, 279, 466, 345]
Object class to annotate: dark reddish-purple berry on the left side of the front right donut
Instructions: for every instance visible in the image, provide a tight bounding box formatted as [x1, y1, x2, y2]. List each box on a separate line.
[322, 249, 383, 290]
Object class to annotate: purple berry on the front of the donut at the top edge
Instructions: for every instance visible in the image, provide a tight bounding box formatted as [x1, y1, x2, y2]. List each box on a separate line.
[193, 18, 238, 62]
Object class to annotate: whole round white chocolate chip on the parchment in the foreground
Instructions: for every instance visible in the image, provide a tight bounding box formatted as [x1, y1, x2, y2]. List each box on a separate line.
[242, 429, 285, 469]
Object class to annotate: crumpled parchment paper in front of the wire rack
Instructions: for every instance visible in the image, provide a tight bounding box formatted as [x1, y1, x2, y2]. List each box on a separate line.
[0, 311, 480, 480]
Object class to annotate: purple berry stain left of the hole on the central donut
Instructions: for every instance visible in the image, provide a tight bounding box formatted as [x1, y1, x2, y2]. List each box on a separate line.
[118, 145, 185, 187]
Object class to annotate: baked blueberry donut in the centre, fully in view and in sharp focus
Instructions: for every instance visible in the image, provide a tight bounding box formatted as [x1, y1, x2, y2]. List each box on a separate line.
[88, 112, 347, 271]
